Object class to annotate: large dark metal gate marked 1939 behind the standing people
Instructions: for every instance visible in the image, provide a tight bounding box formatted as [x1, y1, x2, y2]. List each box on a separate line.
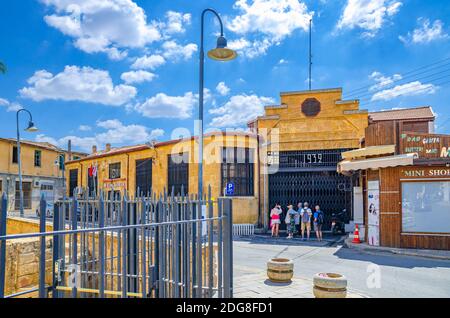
[269, 149, 353, 230]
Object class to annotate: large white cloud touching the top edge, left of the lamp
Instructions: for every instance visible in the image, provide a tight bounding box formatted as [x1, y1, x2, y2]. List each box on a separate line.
[40, 0, 161, 59]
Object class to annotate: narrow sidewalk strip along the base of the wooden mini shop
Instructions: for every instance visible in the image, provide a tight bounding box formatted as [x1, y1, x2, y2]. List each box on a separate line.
[344, 236, 450, 260]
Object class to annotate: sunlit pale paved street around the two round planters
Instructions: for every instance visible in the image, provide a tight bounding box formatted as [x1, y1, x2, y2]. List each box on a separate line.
[234, 238, 450, 298]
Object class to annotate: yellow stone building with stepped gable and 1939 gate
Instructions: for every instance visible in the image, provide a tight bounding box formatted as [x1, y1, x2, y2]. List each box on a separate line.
[249, 88, 368, 227]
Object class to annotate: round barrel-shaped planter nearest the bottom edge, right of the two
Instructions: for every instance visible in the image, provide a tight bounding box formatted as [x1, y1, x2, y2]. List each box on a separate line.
[313, 273, 347, 298]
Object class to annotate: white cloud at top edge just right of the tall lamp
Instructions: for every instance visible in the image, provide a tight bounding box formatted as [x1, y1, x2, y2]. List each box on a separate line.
[226, 0, 314, 58]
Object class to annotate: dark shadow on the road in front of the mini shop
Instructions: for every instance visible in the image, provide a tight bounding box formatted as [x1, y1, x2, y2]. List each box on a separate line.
[334, 247, 450, 268]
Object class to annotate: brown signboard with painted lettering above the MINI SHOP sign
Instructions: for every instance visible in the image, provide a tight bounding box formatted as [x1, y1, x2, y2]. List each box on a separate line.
[400, 133, 450, 159]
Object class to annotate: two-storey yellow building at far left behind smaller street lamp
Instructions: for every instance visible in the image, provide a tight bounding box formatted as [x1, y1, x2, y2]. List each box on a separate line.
[0, 138, 83, 214]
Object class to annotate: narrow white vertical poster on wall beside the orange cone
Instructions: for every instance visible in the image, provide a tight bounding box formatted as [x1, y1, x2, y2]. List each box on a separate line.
[367, 181, 380, 246]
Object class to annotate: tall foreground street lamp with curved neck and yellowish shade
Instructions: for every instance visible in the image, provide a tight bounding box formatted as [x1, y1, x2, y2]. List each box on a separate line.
[198, 9, 237, 202]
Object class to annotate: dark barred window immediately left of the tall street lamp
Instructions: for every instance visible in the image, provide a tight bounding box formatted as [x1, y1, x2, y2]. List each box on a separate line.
[167, 152, 189, 195]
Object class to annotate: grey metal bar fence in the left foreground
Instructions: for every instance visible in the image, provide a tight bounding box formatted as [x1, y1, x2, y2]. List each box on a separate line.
[0, 189, 233, 298]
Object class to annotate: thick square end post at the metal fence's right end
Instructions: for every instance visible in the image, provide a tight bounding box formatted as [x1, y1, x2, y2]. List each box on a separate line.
[223, 199, 233, 298]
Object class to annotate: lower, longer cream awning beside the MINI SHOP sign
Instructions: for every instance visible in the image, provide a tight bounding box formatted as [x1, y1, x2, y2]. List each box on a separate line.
[338, 153, 418, 173]
